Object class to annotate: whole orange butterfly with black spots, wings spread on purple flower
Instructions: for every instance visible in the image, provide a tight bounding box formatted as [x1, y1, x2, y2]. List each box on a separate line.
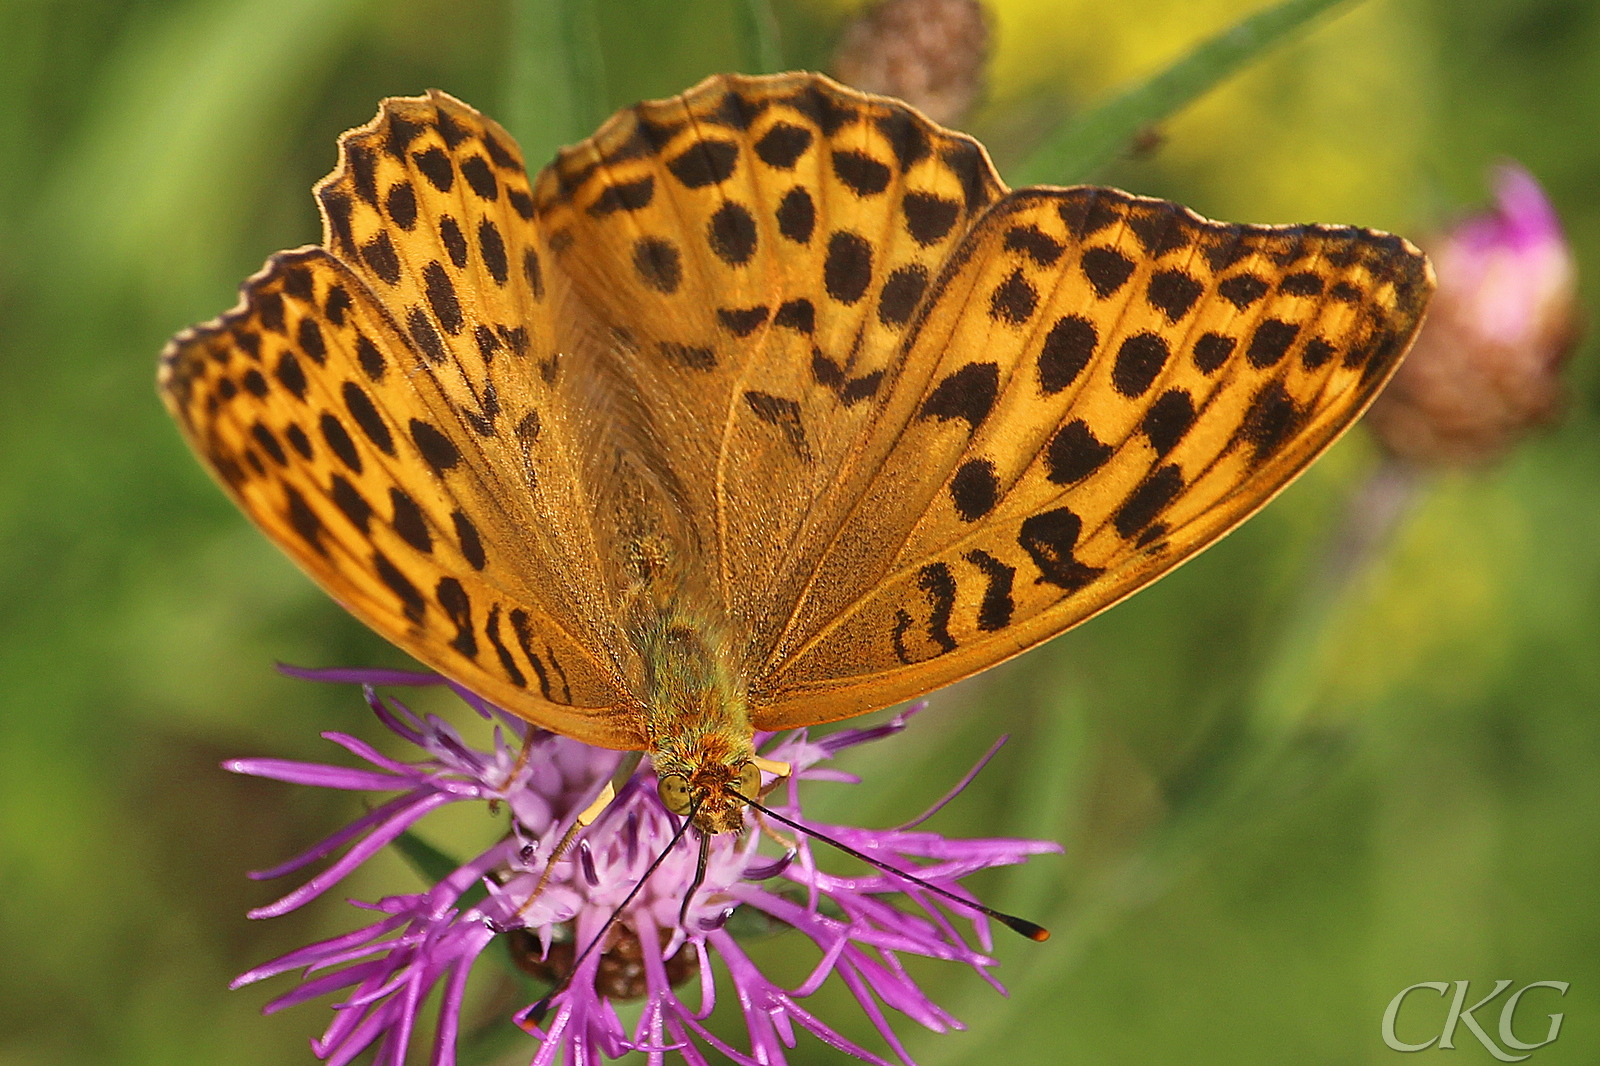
[160, 74, 1434, 832]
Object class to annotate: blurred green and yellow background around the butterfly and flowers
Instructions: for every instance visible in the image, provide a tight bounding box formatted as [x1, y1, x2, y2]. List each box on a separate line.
[0, 0, 1600, 1066]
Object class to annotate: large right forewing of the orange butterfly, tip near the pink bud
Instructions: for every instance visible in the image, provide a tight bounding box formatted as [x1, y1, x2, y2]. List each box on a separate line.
[755, 187, 1432, 728]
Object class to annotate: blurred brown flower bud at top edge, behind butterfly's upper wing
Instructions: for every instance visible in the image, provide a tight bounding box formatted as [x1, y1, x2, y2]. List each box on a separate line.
[834, 0, 989, 125]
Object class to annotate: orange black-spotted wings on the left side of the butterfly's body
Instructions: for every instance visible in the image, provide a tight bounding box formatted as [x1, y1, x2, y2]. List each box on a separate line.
[162, 96, 642, 746]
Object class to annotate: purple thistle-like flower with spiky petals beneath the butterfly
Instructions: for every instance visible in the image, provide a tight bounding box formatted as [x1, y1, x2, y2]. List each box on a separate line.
[224, 671, 1061, 1066]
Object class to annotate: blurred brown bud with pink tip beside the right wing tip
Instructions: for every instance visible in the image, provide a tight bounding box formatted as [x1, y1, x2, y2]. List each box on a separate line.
[1368, 163, 1579, 467]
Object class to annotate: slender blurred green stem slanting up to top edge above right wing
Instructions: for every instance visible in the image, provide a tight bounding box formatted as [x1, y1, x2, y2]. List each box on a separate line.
[1013, 0, 1350, 186]
